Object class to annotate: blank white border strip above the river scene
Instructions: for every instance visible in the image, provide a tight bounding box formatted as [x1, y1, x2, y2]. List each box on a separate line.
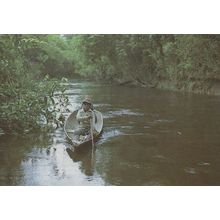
[0, 0, 220, 34]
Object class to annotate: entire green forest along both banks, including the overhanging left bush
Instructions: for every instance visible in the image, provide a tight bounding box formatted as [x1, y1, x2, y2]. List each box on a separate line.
[0, 35, 220, 133]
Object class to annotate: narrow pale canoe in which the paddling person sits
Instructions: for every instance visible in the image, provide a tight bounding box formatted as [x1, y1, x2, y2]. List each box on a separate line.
[64, 110, 103, 149]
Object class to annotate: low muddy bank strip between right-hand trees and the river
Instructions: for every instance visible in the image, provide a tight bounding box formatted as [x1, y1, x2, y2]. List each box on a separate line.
[116, 79, 220, 95]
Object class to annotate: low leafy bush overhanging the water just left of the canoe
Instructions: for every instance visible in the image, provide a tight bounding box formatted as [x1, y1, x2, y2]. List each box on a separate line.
[0, 76, 69, 132]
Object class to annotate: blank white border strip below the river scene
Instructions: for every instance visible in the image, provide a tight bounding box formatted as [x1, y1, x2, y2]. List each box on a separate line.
[0, 186, 220, 220]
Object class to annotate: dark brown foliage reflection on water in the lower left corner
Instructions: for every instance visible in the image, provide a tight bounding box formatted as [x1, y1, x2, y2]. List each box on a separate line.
[0, 133, 51, 185]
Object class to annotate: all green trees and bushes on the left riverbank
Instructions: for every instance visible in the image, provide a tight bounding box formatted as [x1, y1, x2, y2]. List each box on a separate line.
[0, 35, 68, 133]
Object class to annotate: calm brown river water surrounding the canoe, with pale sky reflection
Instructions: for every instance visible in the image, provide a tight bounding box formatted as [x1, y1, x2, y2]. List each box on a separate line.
[0, 81, 220, 185]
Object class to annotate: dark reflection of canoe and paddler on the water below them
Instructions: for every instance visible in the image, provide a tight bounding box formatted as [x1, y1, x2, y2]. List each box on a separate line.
[67, 146, 95, 176]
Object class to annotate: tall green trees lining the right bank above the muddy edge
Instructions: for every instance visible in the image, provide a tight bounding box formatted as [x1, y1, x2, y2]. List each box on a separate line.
[67, 35, 220, 86]
